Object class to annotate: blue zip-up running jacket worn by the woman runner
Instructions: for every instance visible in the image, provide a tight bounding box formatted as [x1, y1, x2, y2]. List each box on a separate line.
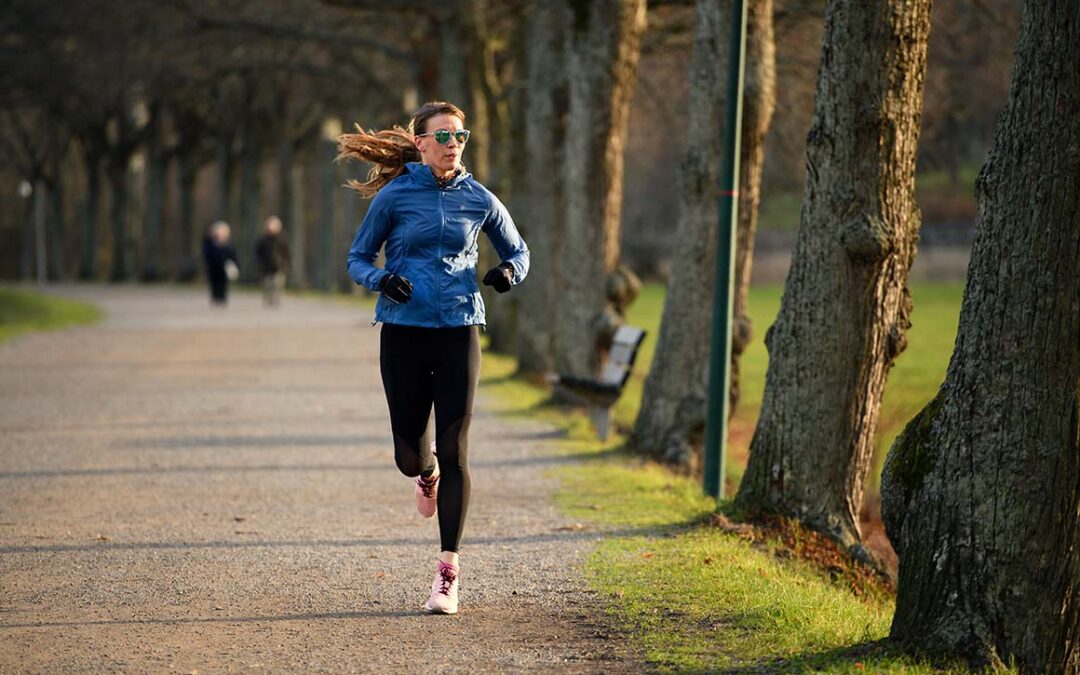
[348, 162, 529, 328]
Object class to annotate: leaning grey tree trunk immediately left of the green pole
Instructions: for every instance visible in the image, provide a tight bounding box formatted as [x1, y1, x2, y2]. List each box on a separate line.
[633, 0, 731, 468]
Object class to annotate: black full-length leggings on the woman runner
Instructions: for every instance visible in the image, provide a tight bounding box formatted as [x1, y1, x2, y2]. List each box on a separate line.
[379, 324, 480, 551]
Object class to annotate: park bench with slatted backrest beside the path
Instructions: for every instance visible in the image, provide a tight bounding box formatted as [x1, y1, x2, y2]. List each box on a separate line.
[555, 325, 645, 441]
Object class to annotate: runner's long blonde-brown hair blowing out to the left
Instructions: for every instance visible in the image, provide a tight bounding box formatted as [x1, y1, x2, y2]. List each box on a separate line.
[337, 100, 465, 198]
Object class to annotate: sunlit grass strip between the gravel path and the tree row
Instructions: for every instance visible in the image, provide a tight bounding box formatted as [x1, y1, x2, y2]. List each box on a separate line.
[482, 345, 984, 673]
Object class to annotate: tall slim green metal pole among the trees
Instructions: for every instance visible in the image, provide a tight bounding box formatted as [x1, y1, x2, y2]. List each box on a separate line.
[704, 0, 746, 500]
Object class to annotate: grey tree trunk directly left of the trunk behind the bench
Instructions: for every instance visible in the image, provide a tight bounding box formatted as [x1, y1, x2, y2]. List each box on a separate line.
[517, 2, 566, 373]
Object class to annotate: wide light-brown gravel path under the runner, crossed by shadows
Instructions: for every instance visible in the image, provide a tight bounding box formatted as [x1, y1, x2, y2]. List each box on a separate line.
[0, 286, 640, 673]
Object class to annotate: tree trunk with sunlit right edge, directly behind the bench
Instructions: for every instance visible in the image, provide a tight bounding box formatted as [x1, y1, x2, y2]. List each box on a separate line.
[556, 0, 645, 377]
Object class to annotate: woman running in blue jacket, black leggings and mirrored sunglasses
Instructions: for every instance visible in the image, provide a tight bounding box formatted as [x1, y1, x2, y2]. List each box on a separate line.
[339, 102, 529, 615]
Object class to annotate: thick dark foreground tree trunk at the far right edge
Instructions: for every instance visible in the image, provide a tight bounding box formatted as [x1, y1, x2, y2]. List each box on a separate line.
[882, 0, 1080, 674]
